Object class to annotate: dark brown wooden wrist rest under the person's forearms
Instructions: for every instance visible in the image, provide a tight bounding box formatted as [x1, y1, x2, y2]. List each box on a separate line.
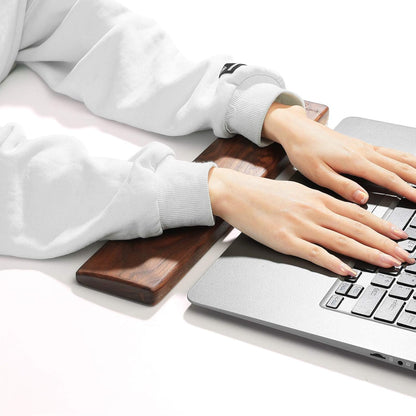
[76, 101, 329, 305]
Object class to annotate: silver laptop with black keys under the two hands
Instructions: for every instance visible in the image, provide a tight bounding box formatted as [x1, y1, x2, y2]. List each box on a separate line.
[188, 117, 416, 371]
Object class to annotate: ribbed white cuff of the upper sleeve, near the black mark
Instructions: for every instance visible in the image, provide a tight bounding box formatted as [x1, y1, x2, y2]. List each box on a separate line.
[226, 77, 305, 147]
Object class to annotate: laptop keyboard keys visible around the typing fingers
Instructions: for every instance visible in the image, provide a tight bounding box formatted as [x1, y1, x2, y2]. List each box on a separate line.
[320, 194, 416, 331]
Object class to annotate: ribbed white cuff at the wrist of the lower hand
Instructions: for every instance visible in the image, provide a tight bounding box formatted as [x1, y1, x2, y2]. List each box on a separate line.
[156, 156, 217, 230]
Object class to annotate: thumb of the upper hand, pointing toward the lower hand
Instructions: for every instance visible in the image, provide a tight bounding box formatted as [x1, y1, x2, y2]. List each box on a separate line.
[313, 165, 368, 205]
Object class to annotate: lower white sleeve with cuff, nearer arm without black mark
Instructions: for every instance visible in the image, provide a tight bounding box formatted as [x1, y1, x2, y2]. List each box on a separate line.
[0, 124, 214, 258]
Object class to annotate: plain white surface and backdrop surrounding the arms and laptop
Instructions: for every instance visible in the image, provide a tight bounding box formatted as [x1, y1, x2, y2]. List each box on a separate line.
[0, 0, 416, 416]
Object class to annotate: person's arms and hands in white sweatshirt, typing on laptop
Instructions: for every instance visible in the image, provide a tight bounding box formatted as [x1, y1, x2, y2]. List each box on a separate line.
[0, 0, 416, 275]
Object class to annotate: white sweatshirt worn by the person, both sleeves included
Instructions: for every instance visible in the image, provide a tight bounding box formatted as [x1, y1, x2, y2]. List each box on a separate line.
[0, 0, 303, 258]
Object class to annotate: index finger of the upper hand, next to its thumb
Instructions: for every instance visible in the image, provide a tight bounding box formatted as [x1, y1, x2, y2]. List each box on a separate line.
[353, 161, 416, 202]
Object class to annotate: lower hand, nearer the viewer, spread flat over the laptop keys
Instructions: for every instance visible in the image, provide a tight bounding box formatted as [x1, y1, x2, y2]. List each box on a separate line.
[209, 167, 415, 276]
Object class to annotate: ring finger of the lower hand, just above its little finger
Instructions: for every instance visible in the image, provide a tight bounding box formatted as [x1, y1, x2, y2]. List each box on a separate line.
[305, 226, 402, 268]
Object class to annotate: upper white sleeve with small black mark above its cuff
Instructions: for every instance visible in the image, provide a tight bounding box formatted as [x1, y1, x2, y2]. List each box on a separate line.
[17, 0, 303, 146]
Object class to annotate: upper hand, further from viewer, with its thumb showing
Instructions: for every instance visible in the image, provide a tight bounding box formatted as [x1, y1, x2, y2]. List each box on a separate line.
[263, 103, 416, 204]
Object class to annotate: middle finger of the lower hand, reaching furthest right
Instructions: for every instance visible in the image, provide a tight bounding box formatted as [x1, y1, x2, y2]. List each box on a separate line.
[320, 213, 414, 263]
